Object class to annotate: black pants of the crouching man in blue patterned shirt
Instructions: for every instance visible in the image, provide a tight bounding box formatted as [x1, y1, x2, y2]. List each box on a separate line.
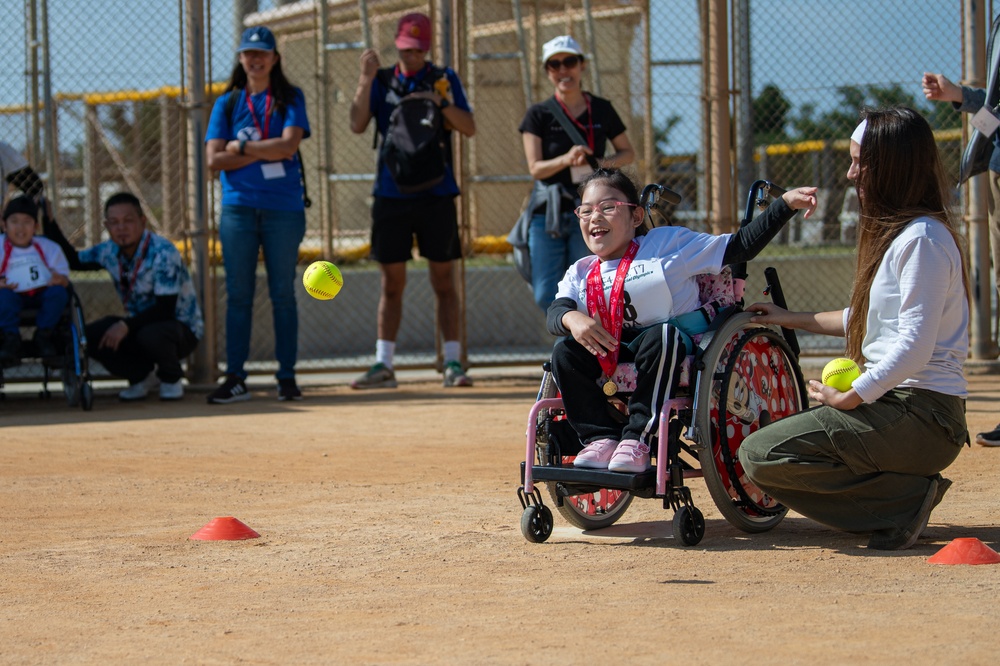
[87, 317, 198, 384]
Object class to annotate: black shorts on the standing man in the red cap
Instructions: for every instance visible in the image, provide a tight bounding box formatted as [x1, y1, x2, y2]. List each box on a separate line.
[372, 197, 462, 264]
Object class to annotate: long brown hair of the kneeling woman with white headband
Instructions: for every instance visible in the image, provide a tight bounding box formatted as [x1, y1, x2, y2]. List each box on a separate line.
[847, 107, 969, 363]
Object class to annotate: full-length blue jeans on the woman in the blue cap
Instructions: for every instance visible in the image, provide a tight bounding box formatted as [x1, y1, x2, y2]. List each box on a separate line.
[219, 206, 306, 379]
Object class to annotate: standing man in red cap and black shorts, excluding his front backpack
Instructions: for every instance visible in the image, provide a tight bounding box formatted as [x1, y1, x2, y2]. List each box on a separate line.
[351, 14, 476, 389]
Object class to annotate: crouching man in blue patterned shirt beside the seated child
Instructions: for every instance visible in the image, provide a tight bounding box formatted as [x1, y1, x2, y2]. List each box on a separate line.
[45, 192, 204, 402]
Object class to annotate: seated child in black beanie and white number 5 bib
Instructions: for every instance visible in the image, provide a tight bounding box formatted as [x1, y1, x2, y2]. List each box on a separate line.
[0, 195, 69, 366]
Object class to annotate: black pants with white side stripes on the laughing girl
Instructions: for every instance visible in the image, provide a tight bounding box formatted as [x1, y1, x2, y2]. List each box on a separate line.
[552, 324, 687, 445]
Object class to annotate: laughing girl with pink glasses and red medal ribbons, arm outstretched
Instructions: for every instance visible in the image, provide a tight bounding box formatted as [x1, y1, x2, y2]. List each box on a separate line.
[547, 169, 816, 473]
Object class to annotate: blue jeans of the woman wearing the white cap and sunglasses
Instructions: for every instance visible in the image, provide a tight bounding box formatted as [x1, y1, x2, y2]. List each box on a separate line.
[528, 211, 591, 312]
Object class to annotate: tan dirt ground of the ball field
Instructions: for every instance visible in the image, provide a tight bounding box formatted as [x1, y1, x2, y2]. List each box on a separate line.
[0, 370, 1000, 666]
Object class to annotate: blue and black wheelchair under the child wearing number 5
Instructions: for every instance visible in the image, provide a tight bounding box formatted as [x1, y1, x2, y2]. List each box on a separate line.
[0, 285, 94, 411]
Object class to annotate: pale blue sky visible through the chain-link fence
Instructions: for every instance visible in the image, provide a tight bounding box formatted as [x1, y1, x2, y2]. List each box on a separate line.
[0, 0, 976, 150]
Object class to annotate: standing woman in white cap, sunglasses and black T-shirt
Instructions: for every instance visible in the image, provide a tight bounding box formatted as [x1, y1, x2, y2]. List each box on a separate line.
[509, 35, 635, 312]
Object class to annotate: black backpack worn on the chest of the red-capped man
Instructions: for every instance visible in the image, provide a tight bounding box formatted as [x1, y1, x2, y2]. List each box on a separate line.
[376, 67, 451, 194]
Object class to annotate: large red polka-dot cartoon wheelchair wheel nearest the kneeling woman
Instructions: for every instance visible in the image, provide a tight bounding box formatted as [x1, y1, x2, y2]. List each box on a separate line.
[695, 312, 807, 533]
